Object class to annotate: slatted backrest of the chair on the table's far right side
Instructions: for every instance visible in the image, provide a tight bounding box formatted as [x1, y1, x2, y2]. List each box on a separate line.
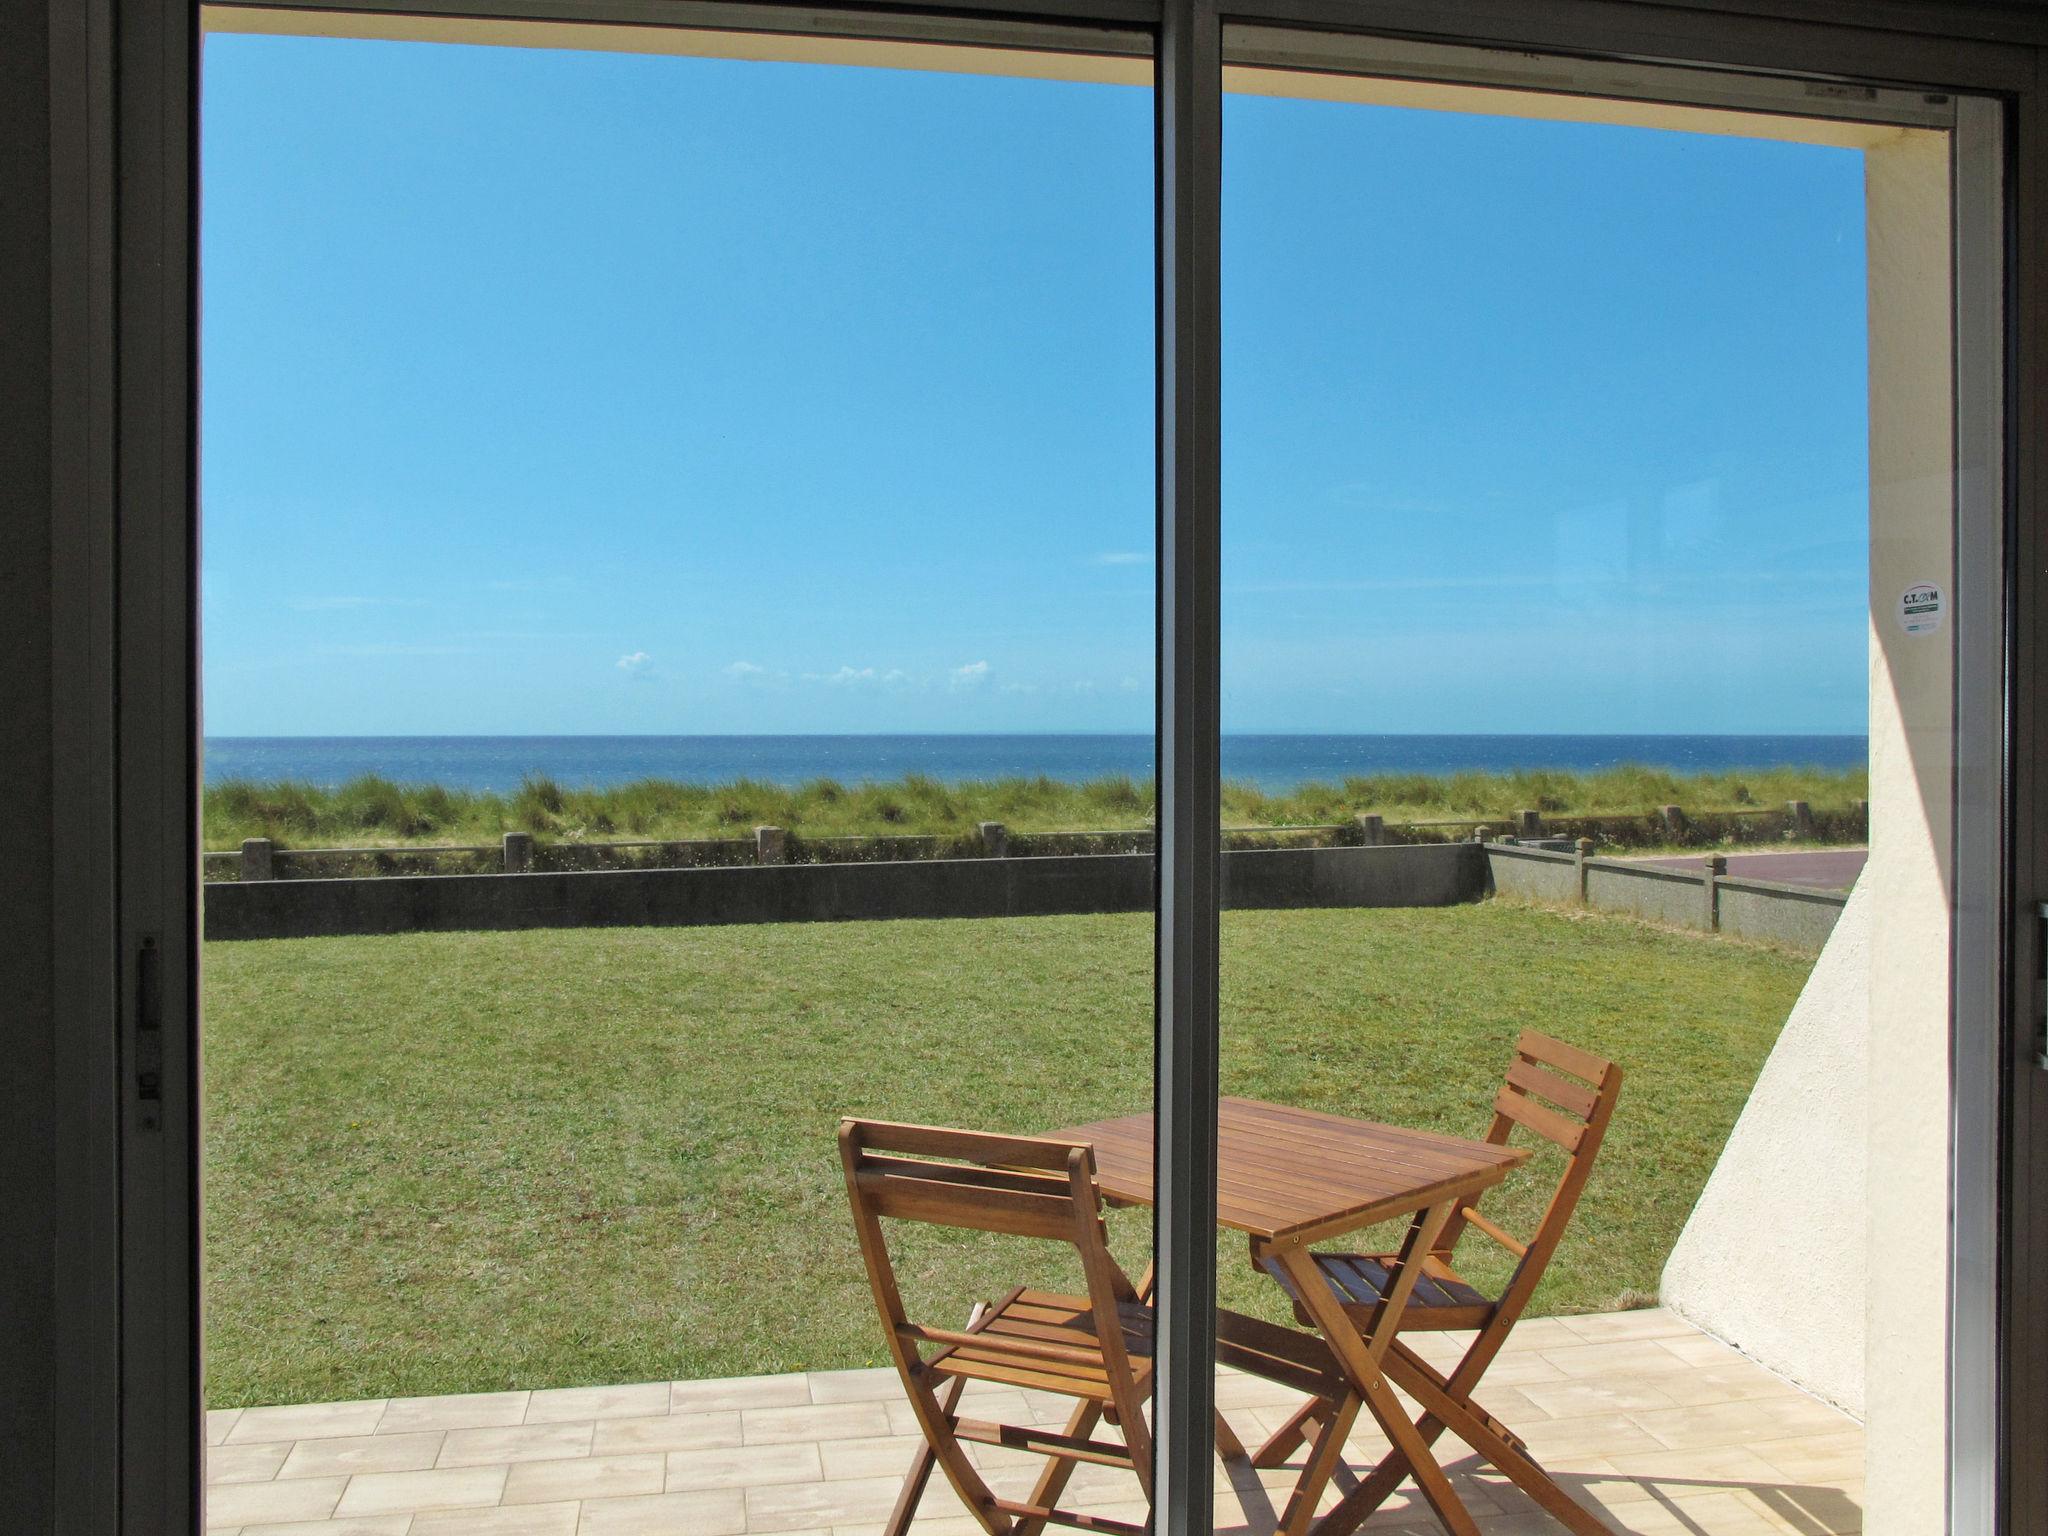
[1436, 1030, 1622, 1321]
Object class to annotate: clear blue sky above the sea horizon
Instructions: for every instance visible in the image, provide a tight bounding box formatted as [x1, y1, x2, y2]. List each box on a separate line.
[203, 37, 1866, 735]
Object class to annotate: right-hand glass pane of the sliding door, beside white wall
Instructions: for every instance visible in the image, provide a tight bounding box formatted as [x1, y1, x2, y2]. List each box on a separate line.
[1219, 39, 1954, 1532]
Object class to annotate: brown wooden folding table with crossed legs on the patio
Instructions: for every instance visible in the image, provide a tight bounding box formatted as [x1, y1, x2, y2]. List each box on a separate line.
[1051, 1098, 1528, 1536]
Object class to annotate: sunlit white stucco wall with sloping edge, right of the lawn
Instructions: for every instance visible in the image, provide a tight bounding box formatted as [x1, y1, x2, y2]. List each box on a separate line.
[1661, 889, 1872, 1417]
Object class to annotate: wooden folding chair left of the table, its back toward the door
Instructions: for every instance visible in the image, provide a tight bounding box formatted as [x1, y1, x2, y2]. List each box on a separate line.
[840, 1118, 1343, 1536]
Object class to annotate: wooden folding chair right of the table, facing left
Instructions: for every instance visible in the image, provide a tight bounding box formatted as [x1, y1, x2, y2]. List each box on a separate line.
[1253, 1030, 1622, 1536]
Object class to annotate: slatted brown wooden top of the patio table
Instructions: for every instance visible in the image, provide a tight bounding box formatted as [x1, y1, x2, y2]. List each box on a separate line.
[1051, 1098, 1528, 1241]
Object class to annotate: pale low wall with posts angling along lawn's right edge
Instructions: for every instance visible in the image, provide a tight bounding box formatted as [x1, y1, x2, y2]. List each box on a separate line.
[1485, 842, 1849, 952]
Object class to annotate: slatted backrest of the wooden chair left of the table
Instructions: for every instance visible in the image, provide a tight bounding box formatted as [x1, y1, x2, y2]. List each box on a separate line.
[840, 1118, 1143, 1425]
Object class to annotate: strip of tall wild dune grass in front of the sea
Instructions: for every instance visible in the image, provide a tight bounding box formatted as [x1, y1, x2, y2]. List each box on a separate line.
[205, 766, 1870, 848]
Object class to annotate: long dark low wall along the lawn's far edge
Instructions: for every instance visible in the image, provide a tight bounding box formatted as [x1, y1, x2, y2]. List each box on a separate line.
[205, 844, 1487, 938]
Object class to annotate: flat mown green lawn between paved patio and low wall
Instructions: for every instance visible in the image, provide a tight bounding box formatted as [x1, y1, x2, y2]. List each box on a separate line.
[203, 901, 1810, 1407]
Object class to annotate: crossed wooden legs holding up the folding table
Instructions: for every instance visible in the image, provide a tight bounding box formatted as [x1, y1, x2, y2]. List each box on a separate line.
[1272, 1200, 1479, 1536]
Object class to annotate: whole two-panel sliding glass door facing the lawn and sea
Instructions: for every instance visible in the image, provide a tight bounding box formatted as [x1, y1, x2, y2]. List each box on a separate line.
[78, 0, 2032, 1536]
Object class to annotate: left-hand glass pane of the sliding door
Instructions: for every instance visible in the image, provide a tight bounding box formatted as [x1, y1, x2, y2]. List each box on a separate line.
[203, 20, 1155, 1530]
